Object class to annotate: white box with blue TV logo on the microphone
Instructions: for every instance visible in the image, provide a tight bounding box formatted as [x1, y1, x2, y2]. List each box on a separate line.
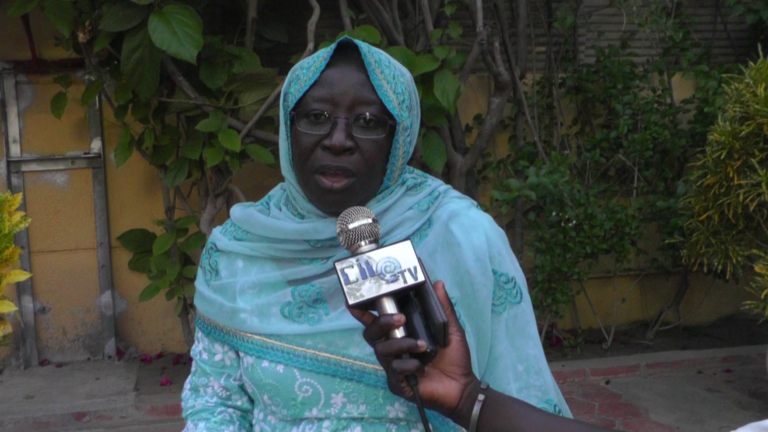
[334, 240, 426, 306]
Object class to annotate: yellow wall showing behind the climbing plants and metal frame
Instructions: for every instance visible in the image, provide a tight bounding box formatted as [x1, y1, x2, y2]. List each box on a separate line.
[0, 2, 746, 361]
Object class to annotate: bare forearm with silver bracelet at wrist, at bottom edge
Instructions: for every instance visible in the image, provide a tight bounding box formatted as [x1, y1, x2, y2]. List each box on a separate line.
[451, 382, 611, 432]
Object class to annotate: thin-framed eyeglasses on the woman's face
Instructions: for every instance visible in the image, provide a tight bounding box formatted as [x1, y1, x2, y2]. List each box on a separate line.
[290, 109, 397, 138]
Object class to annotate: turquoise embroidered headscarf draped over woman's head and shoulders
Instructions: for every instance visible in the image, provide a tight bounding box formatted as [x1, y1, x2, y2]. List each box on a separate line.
[195, 38, 570, 426]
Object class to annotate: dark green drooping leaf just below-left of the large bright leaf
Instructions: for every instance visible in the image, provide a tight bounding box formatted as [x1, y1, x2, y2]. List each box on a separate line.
[120, 26, 162, 100]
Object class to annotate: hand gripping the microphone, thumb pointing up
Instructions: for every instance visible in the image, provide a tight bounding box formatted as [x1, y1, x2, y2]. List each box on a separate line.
[349, 281, 480, 425]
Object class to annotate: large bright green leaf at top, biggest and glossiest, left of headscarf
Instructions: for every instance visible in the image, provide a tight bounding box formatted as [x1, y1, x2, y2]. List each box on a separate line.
[149, 4, 204, 64]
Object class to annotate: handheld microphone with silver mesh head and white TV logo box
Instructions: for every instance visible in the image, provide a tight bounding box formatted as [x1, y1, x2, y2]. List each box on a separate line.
[334, 207, 448, 364]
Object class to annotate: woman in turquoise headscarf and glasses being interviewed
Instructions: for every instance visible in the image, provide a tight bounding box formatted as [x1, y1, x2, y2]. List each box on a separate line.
[182, 38, 570, 432]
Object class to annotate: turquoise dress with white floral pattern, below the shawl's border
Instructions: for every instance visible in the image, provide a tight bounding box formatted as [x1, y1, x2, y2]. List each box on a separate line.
[181, 329, 458, 432]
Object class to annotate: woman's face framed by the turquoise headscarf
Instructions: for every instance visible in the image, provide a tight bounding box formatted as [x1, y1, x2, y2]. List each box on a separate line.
[291, 58, 395, 216]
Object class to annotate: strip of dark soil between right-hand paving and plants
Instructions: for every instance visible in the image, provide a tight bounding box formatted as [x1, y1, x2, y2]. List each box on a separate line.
[544, 315, 768, 361]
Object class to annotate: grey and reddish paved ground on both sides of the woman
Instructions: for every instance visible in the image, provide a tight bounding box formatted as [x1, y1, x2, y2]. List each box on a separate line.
[0, 346, 768, 432]
